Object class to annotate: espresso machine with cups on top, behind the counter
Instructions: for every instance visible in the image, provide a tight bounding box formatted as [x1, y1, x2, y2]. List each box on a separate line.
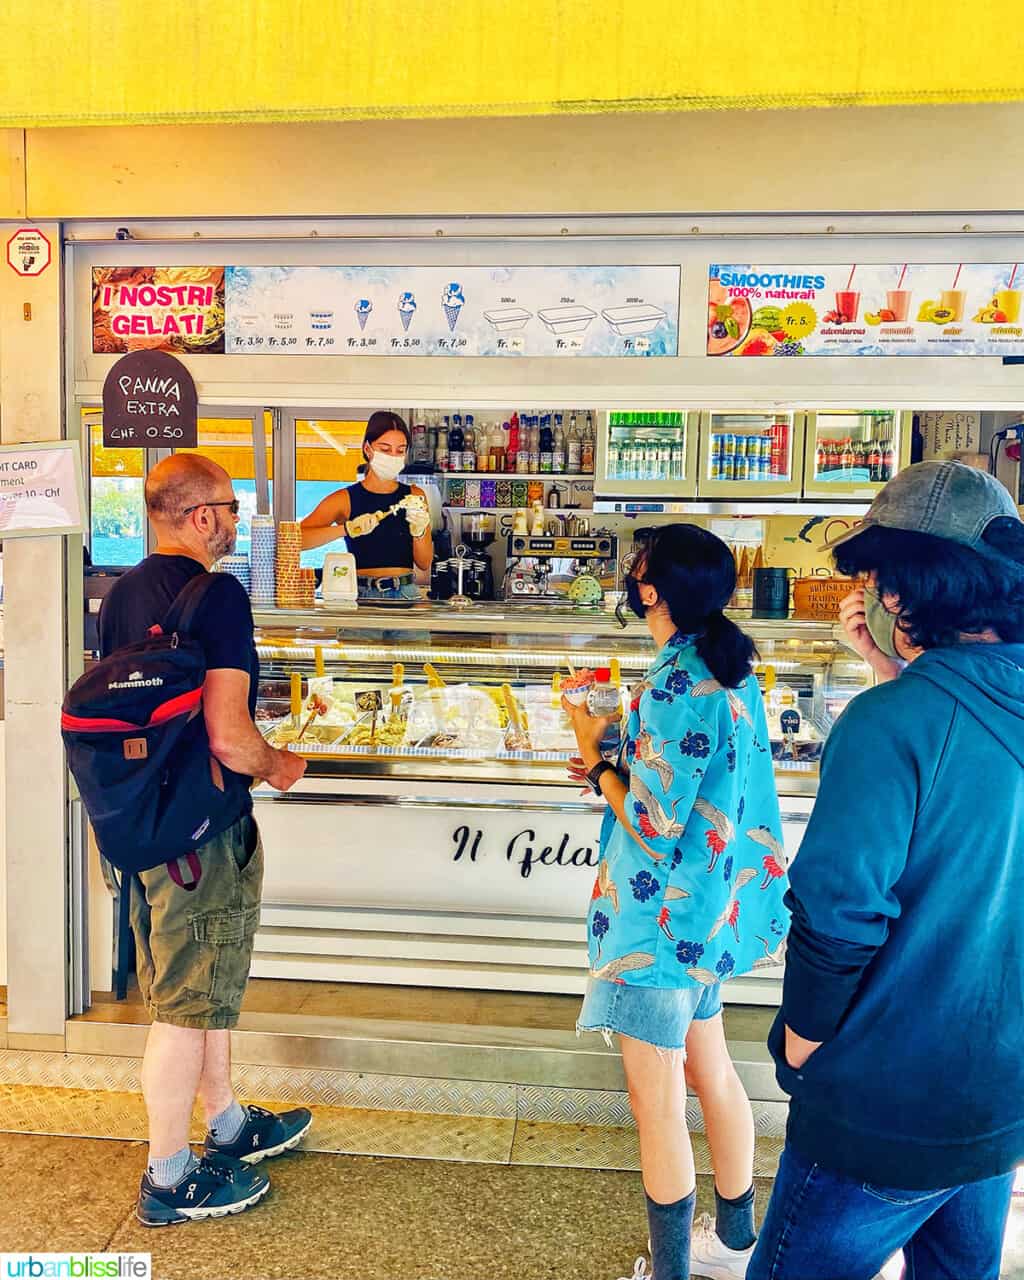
[503, 530, 618, 608]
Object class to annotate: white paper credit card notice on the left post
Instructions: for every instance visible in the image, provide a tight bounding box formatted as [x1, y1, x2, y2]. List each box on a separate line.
[0, 440, 84, 539]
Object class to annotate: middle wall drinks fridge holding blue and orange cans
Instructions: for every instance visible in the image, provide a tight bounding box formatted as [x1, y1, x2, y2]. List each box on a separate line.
[698, 410, 805, 500]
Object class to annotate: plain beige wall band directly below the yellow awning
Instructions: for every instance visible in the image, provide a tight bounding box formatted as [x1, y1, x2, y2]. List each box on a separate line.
[18, 104, 1024, 217]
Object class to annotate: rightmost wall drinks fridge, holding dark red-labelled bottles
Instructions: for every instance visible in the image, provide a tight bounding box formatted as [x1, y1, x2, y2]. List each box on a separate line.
[804, 408, 913, 499]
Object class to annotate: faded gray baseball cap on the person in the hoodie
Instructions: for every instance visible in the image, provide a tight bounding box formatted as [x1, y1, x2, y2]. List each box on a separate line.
[823, 462, 1020, 559]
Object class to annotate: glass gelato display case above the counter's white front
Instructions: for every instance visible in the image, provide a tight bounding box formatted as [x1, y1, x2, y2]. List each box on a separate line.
[257, 604, 870, 795]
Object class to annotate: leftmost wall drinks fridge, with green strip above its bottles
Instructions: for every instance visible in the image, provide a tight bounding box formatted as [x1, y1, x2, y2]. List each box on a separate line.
[594, 410, 700, 498]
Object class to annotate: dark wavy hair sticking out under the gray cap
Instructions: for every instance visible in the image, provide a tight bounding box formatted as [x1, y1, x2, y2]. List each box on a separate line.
[835, 516, 1024, 649]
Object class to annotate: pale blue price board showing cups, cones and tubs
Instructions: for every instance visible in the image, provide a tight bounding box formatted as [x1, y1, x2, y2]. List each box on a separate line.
[225, 266, 680, 357]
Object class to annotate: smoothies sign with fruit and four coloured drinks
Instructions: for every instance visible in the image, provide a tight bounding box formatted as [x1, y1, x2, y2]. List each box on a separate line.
[707, 262, 1024, 357]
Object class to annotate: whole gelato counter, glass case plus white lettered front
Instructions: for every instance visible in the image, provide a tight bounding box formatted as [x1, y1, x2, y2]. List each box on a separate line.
[253, 603, 868, 1004]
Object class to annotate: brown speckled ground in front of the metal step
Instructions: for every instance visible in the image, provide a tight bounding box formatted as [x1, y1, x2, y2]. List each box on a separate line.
[0, 1134, 1024, 1280]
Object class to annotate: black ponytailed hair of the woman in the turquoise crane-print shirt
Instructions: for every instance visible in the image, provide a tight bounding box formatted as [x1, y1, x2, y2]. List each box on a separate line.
[637, 525, 758, 689]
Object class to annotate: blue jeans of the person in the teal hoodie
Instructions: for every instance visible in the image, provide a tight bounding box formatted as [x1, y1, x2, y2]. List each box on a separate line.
[746, 1146, 1014, 1280]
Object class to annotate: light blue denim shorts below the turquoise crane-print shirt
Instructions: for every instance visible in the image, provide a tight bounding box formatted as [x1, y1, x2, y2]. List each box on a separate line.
[576, 978, 722, 1050]
